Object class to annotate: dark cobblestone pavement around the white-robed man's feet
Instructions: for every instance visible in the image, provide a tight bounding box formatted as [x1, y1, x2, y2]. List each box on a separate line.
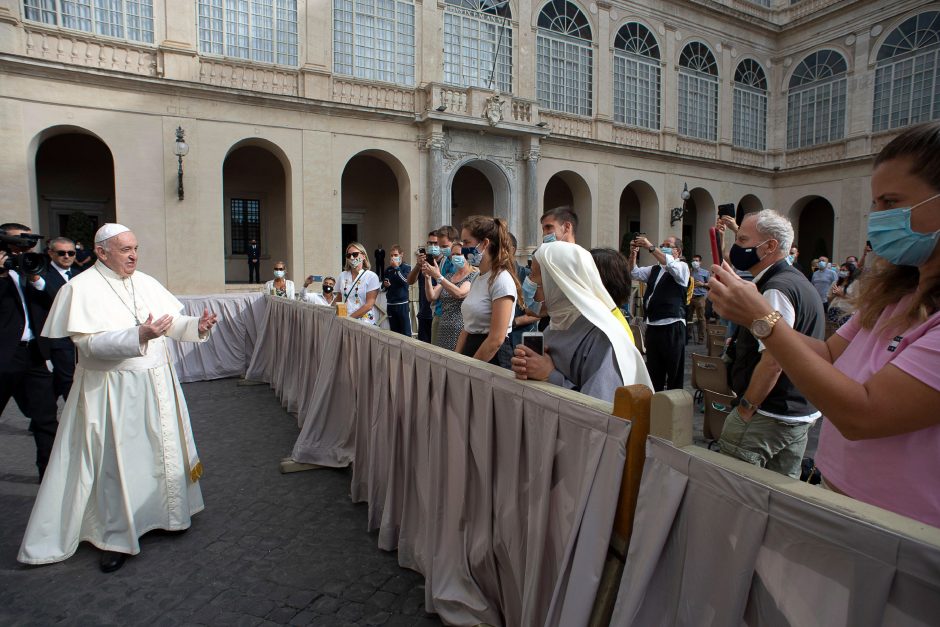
[0, 379, 441, 627]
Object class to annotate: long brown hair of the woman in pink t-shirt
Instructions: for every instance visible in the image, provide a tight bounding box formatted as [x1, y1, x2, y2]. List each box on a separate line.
[856, 122, 940, 330]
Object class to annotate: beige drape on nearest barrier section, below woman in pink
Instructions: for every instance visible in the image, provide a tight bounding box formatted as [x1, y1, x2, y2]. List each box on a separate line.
[611, 438, 940, 627]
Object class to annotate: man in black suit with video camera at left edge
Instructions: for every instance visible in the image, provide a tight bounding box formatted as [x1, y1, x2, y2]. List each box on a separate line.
[0, 223, 58, 480]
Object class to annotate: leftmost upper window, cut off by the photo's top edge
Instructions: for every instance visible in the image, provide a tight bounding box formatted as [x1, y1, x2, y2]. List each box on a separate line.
[23, 0, 153, 44]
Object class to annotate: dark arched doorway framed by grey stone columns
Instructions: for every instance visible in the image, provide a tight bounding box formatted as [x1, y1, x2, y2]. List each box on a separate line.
[450, 159, 518, 231]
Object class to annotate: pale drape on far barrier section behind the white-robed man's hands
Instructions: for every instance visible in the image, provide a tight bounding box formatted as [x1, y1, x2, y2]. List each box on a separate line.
[167, 293, 265, 383]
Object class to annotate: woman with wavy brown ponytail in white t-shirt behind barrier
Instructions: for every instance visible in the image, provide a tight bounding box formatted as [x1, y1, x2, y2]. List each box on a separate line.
[454, 216, 521, 368]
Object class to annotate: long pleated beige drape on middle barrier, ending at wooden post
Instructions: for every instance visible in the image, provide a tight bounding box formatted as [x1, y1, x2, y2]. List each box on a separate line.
[249, 298, 630, 627]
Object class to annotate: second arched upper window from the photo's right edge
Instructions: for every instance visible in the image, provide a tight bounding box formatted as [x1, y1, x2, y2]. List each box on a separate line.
[787, 50, 848, 149]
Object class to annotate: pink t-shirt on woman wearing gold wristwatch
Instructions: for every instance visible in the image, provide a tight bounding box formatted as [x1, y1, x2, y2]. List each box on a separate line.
[816, 297, 940, 527]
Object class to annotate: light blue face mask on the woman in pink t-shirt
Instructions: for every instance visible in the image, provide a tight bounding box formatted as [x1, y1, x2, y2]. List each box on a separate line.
[868, 194, 940, 266]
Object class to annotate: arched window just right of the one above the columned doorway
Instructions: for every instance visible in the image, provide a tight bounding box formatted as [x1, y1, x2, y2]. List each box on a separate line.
[536, 0, 594, 115]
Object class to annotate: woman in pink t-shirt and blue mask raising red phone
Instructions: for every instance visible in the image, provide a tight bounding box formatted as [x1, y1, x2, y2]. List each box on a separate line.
[708, 122, 940, 527]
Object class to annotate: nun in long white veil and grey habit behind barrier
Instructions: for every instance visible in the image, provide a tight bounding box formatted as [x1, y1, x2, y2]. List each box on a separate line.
[512, 242, 652, 402]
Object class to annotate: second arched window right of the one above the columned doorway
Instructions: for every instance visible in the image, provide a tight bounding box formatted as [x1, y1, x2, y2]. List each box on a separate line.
[614, 22, 659, 130]
